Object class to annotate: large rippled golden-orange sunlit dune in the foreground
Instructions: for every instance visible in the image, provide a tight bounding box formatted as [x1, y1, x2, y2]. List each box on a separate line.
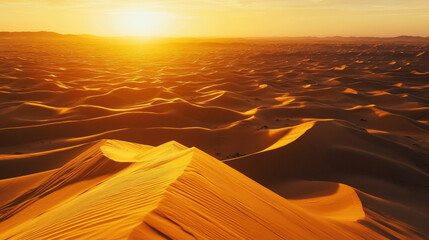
[0, 140, 420, 239]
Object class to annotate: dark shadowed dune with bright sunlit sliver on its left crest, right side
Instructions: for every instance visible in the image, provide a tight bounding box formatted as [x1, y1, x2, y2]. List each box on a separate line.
[224, 120, 429, 186]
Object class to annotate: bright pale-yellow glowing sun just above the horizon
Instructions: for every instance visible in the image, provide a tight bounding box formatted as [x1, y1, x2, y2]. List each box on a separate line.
[114, 11, 170, 36]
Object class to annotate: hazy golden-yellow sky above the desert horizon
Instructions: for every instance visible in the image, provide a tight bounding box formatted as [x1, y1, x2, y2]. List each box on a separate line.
[0, 0, 429, 37]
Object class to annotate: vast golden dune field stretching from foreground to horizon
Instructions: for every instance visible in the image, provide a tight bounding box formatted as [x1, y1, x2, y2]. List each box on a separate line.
[0, 33, 429, 240]
